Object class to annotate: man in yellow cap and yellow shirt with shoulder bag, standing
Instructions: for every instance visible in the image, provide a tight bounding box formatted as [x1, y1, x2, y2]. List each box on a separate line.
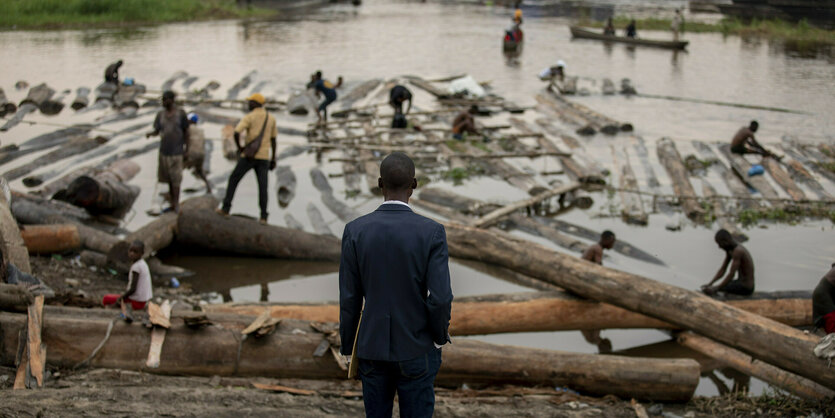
[217, 93, 278, 224]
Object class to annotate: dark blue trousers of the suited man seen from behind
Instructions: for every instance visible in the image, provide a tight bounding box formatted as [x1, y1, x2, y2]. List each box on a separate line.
[358, 348, 441, 418]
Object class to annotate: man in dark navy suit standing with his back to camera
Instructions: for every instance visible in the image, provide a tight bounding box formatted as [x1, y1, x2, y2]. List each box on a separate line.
[339, 152, 452, 417]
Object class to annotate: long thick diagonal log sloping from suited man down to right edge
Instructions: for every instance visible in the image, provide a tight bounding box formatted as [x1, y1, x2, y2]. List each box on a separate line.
[445, 223, 835, 386]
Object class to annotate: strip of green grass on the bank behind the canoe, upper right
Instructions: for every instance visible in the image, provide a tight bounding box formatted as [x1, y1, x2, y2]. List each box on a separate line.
[579, 16, 835, 43]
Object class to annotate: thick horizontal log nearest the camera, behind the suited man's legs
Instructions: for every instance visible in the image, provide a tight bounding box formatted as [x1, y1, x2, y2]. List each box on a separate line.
[0, 309, 699, 401]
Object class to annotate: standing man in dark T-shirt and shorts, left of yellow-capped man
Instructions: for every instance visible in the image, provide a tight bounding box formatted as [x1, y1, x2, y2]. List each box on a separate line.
[145, 90, 189, 212]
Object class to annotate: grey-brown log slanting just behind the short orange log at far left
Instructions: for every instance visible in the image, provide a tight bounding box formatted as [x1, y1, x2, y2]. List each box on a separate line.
[11, 196, 119, 255]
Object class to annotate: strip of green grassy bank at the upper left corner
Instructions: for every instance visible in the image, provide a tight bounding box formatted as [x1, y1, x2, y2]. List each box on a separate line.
[0, 0, 274, 29]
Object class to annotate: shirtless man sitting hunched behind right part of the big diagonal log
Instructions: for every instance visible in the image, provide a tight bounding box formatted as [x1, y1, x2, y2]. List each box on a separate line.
[702, 229, 754, 296]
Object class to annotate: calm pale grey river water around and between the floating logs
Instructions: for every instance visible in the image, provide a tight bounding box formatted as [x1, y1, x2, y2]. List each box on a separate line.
[0, 0, 835, 395]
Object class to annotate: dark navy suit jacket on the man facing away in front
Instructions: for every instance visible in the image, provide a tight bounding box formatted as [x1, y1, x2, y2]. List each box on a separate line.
[339, 203, 452, 361]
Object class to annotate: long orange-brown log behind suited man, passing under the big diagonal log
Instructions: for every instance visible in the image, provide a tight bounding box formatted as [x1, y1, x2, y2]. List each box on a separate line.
[204, 291, 812, 336]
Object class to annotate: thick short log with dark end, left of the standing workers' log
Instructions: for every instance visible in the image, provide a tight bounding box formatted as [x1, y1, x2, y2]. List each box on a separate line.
[54, 163, 140, 218]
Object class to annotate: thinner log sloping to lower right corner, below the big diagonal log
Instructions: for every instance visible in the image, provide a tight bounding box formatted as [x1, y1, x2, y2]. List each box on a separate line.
[677, 331, 835, 400]
